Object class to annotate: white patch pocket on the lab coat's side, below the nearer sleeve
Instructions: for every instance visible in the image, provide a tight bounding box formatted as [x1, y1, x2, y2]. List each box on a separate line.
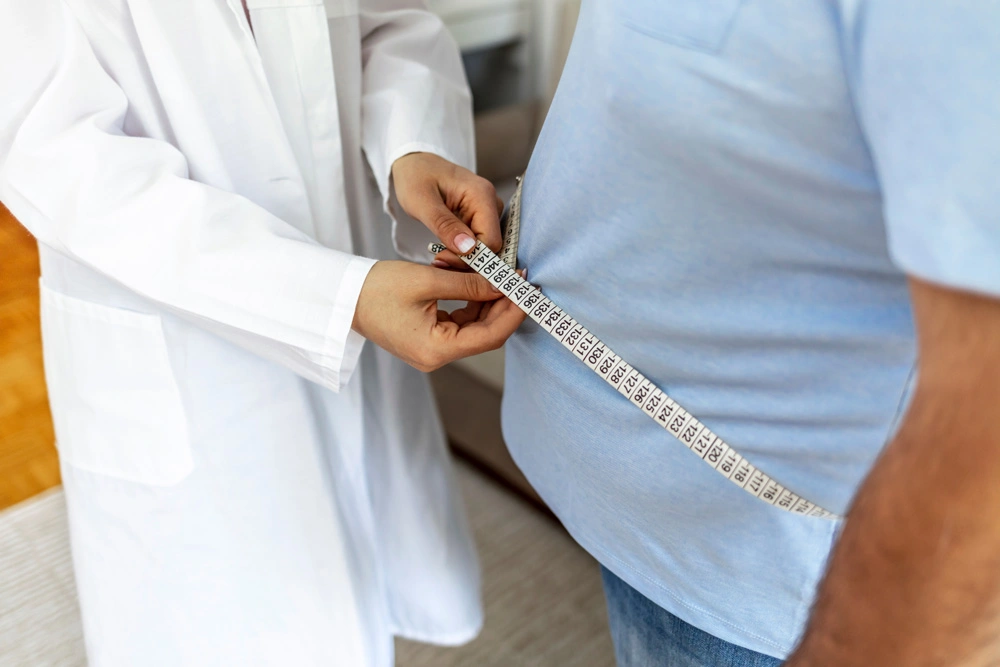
[41, 284, 194, 486]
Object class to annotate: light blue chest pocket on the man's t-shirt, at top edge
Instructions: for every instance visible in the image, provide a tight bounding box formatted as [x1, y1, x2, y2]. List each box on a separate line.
[619, 0, 743, 53]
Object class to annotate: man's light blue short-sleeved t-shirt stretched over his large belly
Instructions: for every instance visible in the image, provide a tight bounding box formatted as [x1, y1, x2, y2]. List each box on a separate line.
[503, 0, 1000, 657]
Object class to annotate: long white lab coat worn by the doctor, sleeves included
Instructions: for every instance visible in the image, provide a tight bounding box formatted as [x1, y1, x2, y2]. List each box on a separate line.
[0, 0, 481, 667]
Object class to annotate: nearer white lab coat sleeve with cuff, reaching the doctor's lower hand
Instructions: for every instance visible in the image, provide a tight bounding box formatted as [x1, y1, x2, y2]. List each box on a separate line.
[0, 0, 374, 390]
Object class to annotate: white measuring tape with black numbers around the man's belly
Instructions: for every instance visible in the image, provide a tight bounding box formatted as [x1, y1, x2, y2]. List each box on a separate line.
[428, 181, 840, 520]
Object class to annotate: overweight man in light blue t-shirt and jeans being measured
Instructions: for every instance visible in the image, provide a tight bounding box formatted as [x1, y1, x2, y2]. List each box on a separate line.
[503, 0, 1000, 667]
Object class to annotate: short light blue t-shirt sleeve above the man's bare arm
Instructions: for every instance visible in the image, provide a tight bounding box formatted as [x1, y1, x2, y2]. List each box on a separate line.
[845, 0, 1000, 295]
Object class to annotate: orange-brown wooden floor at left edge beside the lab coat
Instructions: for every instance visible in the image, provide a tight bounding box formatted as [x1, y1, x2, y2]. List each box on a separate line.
[0, 205, 59, 509]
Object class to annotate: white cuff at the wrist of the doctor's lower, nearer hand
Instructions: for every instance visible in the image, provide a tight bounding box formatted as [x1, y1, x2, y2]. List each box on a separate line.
[323, 257, 376, 391]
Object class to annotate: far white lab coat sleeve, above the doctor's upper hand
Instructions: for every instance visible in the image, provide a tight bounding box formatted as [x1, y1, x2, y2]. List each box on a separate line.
[360, 0, 476, 262]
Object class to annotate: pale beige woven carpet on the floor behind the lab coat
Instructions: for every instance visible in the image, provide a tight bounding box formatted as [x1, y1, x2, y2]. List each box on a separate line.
[0, 462, 614, 667]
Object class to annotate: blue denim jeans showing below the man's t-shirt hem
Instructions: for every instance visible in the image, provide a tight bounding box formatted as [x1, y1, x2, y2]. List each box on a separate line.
[601, 567, 781, 667]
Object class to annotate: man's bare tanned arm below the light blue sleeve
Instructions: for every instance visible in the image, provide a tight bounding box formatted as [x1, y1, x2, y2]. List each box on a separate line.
[787, 279, 1000, 667]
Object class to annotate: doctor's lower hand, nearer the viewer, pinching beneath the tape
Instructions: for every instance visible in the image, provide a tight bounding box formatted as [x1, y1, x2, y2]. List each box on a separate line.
[352, 261, 525, 372]
